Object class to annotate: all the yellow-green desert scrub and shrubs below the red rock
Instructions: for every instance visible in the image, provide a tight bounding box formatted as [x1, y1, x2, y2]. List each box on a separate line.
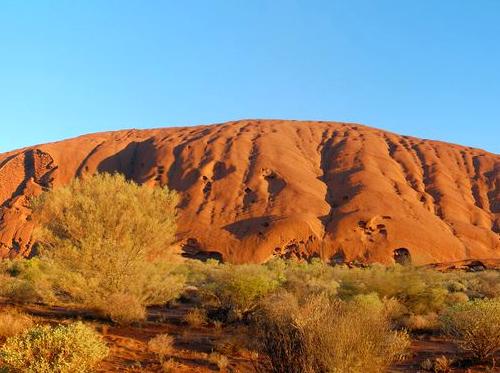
[0, 175, 500, 373]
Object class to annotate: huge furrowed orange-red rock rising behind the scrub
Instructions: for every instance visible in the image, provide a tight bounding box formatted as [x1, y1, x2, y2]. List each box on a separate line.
[0, 120, 500, 264]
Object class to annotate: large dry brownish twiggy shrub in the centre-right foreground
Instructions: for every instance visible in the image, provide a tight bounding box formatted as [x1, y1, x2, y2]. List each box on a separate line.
[256, 293, 409, 373]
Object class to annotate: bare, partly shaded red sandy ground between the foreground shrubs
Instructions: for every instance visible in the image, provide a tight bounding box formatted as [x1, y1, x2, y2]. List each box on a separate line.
[0, 303, 500, 373]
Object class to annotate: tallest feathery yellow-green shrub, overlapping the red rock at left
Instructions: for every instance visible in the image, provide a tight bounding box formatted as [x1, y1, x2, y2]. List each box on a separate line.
[27, 174, 184, 322]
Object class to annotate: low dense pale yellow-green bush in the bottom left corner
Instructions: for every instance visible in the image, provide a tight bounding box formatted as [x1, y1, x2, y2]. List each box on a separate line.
[0, 323, 108, 373]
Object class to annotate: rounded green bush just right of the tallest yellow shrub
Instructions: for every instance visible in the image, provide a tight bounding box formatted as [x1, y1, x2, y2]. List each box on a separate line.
[192, 264, 280, 320]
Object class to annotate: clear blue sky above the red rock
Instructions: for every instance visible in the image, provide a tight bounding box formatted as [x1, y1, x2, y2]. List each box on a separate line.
[0, 0, 500, 153]
